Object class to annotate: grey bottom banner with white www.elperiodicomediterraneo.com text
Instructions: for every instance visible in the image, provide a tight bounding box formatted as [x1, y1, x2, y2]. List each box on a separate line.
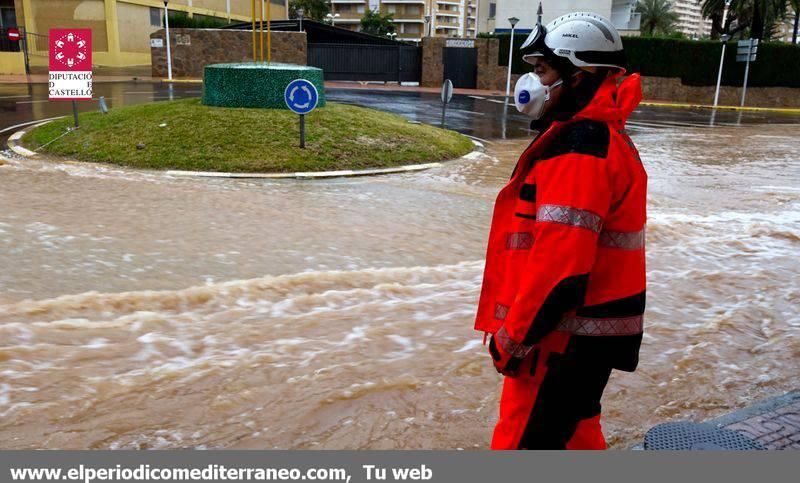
[0, 451, 800, 483]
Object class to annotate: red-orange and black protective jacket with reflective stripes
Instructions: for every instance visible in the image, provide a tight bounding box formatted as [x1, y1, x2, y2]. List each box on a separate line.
[475, 75, 647, 371]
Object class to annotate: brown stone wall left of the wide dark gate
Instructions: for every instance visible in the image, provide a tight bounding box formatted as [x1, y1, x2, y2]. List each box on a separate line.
[150, 29, 307, 79]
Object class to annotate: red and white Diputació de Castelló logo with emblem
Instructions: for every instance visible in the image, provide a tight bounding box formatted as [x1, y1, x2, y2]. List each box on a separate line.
[49, 29, 92, 101]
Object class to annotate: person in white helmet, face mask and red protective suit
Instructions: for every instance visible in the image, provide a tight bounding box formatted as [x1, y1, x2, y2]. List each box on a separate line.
[475, 13, 647, 449]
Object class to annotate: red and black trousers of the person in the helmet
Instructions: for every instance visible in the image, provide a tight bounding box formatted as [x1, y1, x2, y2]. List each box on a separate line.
[492, 332, 611, 450]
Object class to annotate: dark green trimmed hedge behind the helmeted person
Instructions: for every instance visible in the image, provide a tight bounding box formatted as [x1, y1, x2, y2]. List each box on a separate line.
[487, 34, 800, 87]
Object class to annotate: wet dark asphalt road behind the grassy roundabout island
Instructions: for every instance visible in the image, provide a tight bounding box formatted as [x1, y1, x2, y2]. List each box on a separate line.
[0, 81, 800, 145]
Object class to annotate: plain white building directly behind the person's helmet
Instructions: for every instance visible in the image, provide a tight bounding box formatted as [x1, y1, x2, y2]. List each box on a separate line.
[478, 0, 640, 35]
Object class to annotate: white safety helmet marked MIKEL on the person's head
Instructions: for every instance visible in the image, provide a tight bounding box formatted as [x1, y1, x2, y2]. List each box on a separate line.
[520, 12, 625, 73]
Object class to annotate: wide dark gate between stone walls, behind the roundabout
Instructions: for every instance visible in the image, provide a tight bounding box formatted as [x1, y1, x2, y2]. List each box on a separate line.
[308, 42, 422, 82]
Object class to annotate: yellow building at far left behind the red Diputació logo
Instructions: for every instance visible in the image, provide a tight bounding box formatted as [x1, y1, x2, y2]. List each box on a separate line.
[7, 0, 288, 67]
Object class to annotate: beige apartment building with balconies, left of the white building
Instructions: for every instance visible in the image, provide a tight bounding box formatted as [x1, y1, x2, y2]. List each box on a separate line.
[331, 0, 485, 42]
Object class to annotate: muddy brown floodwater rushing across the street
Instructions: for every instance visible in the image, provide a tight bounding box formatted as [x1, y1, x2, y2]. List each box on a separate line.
[0, 122, 800, 449]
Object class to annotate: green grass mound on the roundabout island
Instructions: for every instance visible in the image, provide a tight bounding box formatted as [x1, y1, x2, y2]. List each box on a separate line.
[22, 99, 473, 173]
